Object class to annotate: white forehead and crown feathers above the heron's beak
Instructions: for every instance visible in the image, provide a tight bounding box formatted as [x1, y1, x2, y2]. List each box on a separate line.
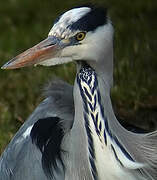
[49, 7, 91, 38]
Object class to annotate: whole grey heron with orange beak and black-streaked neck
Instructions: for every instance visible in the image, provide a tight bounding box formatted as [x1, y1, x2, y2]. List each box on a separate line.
[0, 6, 157, 180]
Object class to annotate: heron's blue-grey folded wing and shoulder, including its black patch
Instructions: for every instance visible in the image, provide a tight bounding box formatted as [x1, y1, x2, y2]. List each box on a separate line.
[0, 81, 74, 180]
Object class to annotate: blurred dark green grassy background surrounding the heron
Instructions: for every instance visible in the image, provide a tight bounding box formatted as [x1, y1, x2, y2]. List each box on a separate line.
[0, 0, 157, 153]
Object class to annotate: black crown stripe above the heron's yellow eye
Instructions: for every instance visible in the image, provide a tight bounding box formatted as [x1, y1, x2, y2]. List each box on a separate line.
[69, 6, 107, 32]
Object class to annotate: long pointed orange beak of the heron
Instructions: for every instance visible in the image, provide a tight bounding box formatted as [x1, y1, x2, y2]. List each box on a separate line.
[1, 36, 61, 69]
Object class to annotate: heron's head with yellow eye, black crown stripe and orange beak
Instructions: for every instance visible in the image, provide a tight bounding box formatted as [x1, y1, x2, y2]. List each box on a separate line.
[2, 6, 113, 69]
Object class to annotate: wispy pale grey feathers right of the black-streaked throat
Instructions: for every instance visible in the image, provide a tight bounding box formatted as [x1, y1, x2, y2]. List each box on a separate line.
[110, 114, 157, 180]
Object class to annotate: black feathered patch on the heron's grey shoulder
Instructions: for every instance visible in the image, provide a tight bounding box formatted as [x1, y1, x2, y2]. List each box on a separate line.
[31, 117, 64, 177]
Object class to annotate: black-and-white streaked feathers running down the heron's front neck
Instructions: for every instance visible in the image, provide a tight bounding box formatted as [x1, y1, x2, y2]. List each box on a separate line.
[77, 63, 134, 173]
